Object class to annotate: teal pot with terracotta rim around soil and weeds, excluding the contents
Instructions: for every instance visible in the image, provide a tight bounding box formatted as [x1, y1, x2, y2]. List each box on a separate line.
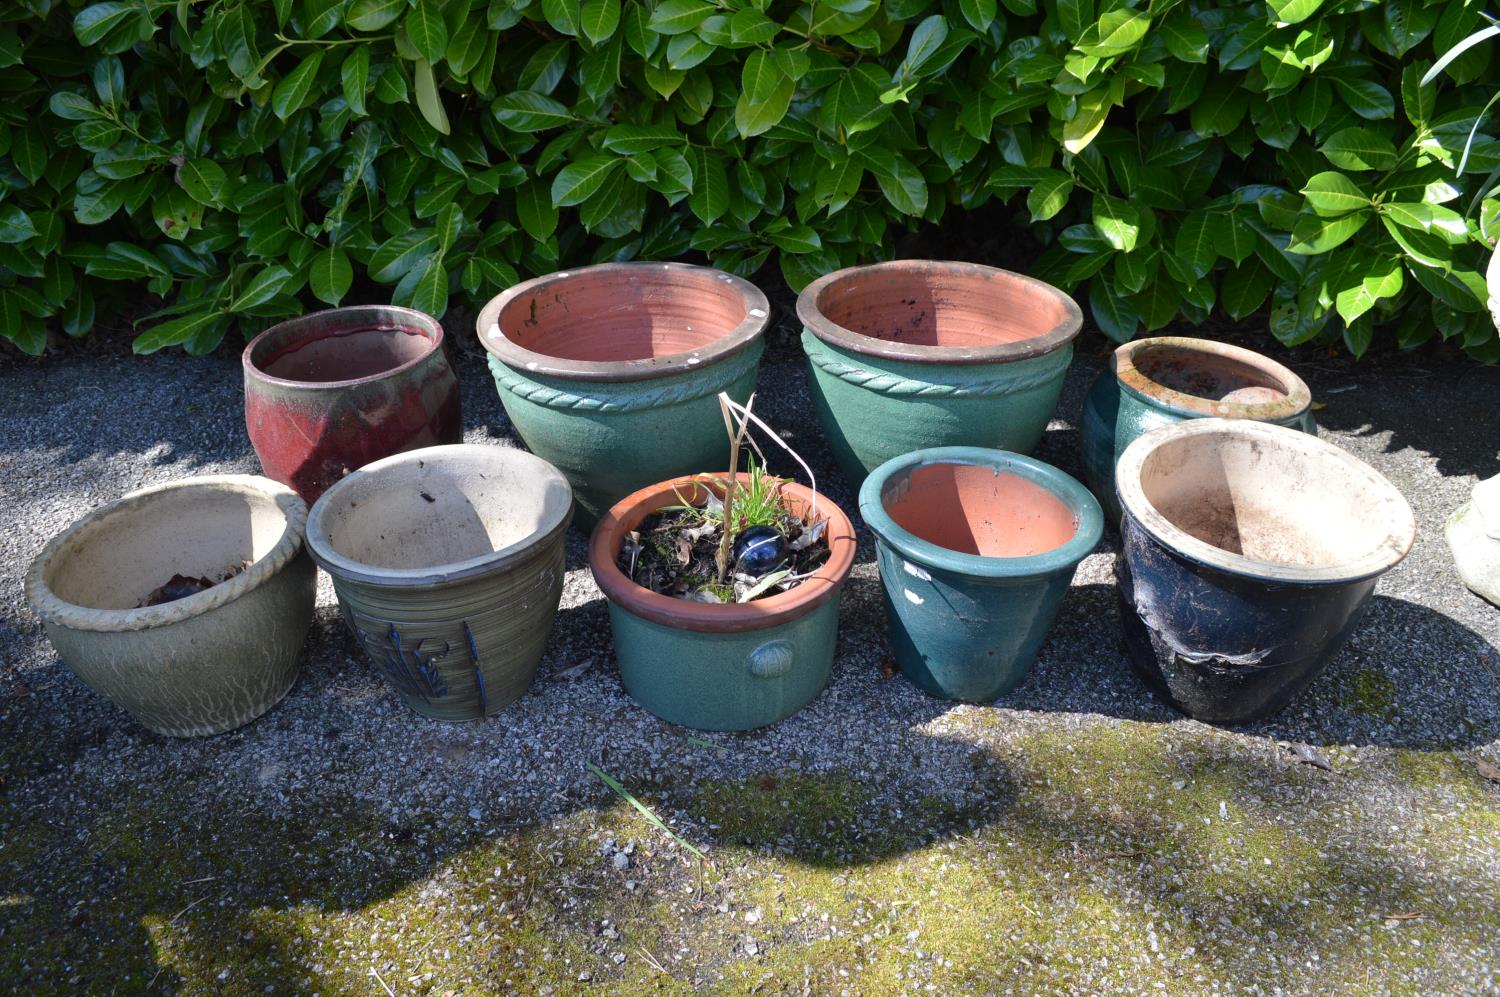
[588, 475, 855, 730]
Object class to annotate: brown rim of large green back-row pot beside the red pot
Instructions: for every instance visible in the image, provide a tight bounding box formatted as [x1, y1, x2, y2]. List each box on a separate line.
[474, 261, 771, 381]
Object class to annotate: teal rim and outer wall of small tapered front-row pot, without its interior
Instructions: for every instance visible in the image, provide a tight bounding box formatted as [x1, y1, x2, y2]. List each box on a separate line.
[860, 447, 1104, 702]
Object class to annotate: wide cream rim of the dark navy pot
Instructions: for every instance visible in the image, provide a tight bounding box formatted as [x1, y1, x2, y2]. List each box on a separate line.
[1115, 418, 1416, 585]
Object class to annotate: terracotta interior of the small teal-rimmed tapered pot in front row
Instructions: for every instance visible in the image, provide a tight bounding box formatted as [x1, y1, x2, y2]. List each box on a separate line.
[881, 463, 1079, 558]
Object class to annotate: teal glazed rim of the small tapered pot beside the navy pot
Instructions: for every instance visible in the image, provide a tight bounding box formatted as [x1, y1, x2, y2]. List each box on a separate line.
[860, 447, 1104, 579]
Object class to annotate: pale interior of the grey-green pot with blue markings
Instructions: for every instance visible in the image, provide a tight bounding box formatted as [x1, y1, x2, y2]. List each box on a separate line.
[323, 448, 573, 568]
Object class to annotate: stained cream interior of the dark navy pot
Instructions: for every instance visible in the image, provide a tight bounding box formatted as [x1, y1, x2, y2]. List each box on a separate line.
[1140, 433, 1404, 568]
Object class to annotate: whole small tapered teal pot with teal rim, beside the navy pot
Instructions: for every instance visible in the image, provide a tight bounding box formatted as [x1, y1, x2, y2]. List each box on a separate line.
[860, 447, 1104, 703]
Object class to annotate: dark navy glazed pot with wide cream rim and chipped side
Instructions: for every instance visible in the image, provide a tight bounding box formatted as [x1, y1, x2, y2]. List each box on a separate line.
[1116, 418, 1416, 723]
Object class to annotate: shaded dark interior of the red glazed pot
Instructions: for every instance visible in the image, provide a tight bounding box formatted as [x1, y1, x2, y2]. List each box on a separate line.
[251, 316, 437, 384]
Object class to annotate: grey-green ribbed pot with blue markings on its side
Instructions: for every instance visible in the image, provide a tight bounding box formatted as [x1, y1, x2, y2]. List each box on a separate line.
[308, 445, 573, 721]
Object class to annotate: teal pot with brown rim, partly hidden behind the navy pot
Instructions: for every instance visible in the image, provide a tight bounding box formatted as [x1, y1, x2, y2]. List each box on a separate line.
[1083, 336, 1317, 523]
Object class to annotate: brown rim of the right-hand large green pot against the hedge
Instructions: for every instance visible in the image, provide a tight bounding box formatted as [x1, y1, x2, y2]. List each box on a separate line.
[797, 259, 1083, 364]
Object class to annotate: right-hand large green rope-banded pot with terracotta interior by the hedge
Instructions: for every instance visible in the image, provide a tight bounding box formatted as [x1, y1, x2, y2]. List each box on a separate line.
[797, 259, 1083, 486]
